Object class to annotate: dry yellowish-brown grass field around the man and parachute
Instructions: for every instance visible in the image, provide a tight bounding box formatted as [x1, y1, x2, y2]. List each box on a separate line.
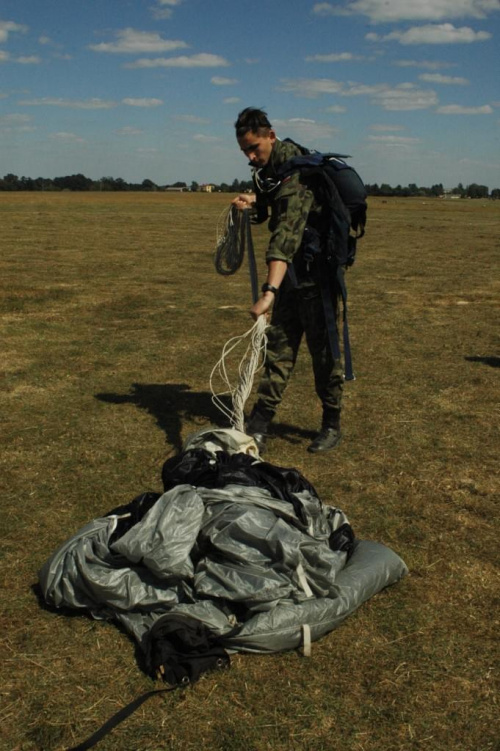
[0, 193, 500, 751]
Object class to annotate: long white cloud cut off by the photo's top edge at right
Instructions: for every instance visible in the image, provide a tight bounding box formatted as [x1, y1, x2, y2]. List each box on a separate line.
[313, 0, 500, 23]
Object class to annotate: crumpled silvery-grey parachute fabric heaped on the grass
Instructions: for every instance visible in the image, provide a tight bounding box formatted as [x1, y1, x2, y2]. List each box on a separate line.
[39, 430, 407, 668]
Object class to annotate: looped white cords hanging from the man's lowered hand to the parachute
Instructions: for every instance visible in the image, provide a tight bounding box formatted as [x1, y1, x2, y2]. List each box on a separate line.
[210, 315, 267, 433]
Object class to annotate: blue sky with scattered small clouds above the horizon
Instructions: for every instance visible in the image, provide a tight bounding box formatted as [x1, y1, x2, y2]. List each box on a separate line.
[0, 0, 500, 189]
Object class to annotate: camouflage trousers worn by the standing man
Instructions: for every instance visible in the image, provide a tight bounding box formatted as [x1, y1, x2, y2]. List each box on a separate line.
[254, 285, 344, 420]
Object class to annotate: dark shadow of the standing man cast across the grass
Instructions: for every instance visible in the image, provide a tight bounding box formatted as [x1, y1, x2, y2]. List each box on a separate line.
[95, 383, 316, 451]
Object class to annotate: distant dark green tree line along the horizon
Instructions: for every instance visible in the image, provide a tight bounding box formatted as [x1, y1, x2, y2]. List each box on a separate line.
[0, 173, 500, 199]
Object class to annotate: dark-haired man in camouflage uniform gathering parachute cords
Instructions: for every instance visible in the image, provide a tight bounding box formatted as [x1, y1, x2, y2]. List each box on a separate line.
[233, 107, 343, 453]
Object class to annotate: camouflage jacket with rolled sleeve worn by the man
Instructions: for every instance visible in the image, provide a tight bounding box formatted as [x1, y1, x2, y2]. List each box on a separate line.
[253, 140, 321, 276]
